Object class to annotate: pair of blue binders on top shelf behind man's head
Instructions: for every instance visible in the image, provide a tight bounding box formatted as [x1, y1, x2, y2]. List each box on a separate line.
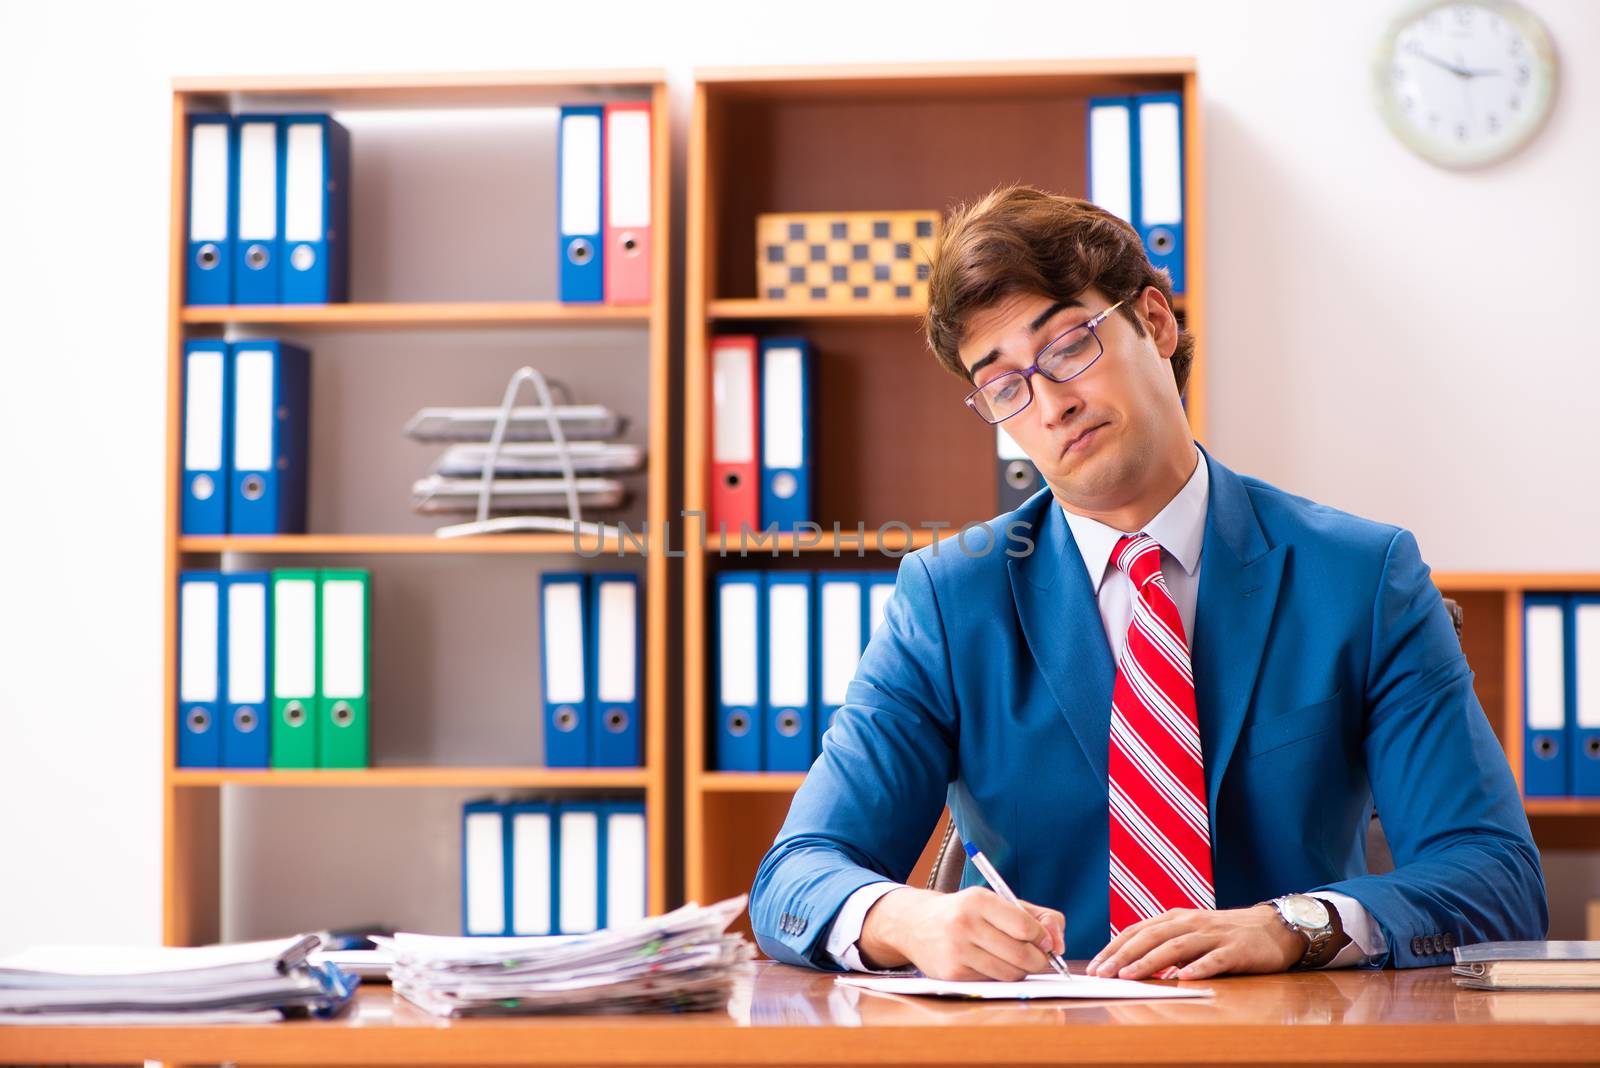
[1088, 93, 1184, 294]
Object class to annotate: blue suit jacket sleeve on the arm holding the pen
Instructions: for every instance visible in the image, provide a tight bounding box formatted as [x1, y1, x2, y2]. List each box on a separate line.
[750, 555, 955, 970]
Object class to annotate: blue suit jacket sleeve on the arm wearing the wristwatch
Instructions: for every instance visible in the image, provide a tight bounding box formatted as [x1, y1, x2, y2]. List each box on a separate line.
[1318, 531, 1549, 967]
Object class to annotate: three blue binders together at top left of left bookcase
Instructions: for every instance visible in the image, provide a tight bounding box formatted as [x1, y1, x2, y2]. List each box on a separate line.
[184, 115, 350, 304]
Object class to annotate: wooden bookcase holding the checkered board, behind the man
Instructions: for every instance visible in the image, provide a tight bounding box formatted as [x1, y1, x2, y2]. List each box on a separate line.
[683, 59, 1206, 902]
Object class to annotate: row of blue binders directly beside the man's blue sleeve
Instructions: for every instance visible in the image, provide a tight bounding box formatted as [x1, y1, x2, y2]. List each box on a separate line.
[710, 571, 894, 771]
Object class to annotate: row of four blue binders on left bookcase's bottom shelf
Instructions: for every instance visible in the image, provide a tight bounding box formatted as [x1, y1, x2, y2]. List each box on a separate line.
[461, 801, 650, 935]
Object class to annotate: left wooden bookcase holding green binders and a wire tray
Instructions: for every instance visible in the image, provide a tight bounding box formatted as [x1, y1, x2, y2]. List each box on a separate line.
[162, 70, 675, 945]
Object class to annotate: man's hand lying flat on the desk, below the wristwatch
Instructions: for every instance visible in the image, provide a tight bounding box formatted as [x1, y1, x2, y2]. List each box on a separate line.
[1088, 905, 1306, 978]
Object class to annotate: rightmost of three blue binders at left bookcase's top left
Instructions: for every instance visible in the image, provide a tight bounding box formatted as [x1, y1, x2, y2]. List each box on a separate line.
[280, 115, 350, 304]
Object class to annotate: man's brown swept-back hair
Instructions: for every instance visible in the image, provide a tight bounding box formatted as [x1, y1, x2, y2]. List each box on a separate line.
[923, 185, 1195, 395]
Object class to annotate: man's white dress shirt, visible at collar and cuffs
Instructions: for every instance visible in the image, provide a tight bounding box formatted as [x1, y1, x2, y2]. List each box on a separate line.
[827, 449, 1387, 972]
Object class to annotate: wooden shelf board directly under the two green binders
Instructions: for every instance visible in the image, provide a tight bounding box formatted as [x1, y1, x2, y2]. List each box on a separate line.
[168, 767, 650, 790]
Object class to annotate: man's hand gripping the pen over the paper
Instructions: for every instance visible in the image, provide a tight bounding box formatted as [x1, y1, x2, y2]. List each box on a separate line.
[858, 886, 1066, 980]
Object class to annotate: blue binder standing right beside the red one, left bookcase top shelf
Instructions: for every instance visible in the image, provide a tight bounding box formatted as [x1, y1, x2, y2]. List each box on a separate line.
[557, 106, 605, 302]
